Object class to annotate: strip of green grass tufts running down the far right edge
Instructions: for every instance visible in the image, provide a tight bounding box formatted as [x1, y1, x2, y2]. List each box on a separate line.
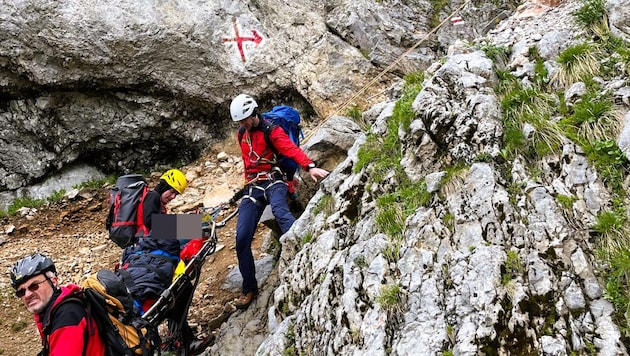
[561, 6, 630, 330]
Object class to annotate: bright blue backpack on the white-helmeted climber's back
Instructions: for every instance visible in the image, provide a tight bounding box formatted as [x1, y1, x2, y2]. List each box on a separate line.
[261, 105, 304, 180]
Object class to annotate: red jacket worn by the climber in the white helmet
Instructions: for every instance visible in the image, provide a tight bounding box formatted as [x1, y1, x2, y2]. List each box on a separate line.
[237, 119, 313, 180]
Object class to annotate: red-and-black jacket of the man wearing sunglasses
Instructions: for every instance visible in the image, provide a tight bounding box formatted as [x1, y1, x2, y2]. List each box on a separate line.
[34, 284, 105, 356]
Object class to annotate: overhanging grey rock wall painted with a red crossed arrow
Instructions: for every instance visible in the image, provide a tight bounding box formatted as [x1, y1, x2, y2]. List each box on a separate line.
[0, 0, 508, 206]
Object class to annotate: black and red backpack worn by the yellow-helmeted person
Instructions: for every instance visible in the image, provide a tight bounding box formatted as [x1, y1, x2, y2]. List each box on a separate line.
[105, 174, 149, 248]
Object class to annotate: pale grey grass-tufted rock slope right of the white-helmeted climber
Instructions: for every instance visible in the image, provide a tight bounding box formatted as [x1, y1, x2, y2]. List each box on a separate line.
[207, 2, 630, 355]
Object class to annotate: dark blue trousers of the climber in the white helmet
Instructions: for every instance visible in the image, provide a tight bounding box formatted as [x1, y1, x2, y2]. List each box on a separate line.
[236, 181, 295, 294]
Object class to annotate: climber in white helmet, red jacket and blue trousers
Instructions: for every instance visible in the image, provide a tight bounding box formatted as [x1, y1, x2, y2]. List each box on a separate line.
[230, 94, 328, 309]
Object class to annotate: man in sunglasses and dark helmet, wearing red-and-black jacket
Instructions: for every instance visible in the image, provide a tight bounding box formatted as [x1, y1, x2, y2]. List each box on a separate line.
[10, 253, 105, 356]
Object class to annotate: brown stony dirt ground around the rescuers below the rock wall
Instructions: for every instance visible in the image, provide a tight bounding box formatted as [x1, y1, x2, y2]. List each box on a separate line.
[0, 149, 268, 356]
